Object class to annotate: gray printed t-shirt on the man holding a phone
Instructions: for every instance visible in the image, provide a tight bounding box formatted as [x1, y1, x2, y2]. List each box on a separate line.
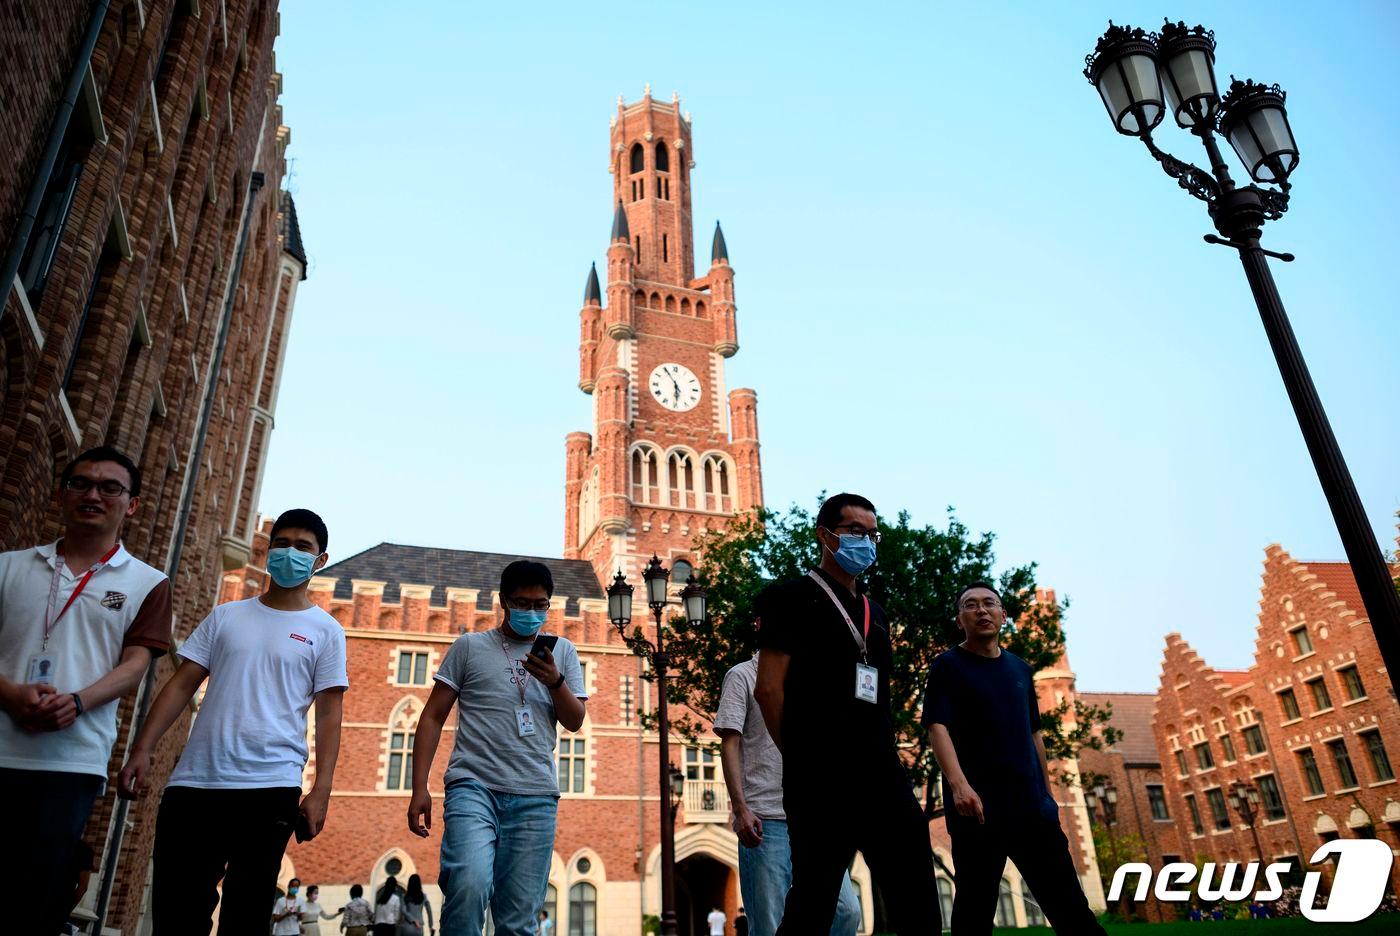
[434, 627, 588, 796]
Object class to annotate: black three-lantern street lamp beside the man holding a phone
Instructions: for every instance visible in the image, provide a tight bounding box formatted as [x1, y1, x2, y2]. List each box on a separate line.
[608, 555, 706, 936]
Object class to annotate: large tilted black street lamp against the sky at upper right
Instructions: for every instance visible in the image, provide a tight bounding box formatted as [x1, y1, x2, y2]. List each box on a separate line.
[1084, 21, 1400, 691]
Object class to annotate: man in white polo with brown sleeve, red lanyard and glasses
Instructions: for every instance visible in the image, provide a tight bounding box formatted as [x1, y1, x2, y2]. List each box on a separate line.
[0, 446, 171, 933]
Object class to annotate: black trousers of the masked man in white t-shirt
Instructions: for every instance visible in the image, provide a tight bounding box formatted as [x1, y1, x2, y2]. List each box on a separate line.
[151, 786, 301, 936]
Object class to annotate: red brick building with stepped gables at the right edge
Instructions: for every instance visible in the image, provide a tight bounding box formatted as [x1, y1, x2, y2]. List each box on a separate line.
[1154, 544, 1400, 886]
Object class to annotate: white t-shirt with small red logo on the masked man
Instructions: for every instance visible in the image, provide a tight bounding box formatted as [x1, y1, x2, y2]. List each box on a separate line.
[169, 597, 350, 789]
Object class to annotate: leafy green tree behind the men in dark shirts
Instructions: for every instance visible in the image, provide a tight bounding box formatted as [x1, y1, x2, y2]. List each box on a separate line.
[634, 495, 1119, 783]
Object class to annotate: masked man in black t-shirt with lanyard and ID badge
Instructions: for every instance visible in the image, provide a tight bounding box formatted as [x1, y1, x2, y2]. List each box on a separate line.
[753, 494, 942, 936]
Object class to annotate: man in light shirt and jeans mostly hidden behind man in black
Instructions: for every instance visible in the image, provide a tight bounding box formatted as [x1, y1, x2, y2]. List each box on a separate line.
[714, 656, 861, 936]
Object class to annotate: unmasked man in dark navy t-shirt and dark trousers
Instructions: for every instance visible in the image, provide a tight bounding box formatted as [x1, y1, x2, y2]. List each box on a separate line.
[924, 582, 1103, 936]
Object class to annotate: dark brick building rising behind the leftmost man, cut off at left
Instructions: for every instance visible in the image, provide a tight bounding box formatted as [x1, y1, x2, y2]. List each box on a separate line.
[0, 0, 305, 933]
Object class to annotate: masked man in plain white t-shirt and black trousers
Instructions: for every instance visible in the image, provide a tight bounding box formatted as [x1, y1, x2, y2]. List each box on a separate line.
[119, 509, 349, 936]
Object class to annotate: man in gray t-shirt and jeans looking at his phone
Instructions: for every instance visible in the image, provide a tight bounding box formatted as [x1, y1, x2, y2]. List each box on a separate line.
[409, 560, 588, 936]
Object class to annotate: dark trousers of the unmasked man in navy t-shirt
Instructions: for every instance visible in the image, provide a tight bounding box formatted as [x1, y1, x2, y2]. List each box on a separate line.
[948, 813, 1103, 936]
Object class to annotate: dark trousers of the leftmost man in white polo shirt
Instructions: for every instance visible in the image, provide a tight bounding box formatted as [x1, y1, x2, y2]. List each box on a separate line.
[0, 768, 102, 933]
